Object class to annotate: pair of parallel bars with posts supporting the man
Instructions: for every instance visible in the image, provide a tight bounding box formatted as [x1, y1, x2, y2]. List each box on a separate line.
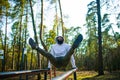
[0, 69, 77, 80]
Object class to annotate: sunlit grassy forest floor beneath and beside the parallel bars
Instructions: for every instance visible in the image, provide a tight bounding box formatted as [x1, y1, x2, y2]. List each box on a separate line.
[3, 71, 120, 80]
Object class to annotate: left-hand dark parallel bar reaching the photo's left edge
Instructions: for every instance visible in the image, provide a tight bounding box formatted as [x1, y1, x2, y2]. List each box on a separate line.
[0, 69, 50, 80]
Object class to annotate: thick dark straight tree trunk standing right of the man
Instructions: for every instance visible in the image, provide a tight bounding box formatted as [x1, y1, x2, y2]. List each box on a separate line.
[96, 0, 104, 75]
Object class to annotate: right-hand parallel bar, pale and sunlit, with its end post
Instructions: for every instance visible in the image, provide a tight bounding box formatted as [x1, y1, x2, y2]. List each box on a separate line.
[52, 69, 77, 80]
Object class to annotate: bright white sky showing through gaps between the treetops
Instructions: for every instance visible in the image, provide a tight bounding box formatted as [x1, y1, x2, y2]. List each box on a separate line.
[39, 0, 120, 37]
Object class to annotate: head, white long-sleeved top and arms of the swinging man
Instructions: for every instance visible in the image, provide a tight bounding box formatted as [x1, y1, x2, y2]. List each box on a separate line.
[48, 36, 76, 69]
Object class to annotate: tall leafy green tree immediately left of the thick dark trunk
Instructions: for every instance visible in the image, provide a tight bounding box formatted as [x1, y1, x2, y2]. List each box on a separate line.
[85, 1, 98, 70]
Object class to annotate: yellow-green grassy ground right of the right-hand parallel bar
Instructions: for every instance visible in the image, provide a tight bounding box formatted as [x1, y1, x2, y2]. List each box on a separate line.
[77, 71, 120, 80]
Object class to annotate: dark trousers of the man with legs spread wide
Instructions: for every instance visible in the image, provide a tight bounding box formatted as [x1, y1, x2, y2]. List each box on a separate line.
[36, 47, 74, 68]
